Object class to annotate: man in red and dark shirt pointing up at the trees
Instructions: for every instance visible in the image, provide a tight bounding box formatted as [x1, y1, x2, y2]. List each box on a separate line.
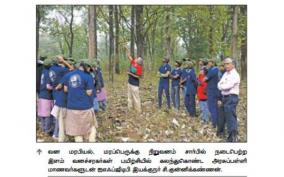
[125, 47, 143, 113]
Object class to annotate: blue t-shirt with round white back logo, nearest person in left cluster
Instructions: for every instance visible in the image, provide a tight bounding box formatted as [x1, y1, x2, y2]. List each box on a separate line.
[64, 69, 94, 110]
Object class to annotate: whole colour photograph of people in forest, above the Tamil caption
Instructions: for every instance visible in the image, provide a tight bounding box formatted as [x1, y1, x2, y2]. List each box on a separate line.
[36, 4, 248, 143]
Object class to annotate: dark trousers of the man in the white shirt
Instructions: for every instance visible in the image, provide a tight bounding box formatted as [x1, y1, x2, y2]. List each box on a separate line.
[218, 95, 239, 136]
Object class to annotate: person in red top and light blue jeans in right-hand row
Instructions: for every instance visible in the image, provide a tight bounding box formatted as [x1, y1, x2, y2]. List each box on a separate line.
[197, 66, 210, 123]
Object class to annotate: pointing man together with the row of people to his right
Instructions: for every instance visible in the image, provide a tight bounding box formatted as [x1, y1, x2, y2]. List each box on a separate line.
[127, 50, 240, 142]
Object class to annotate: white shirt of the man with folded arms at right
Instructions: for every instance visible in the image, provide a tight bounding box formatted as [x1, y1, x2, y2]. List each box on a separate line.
[218, 68, 240, 95]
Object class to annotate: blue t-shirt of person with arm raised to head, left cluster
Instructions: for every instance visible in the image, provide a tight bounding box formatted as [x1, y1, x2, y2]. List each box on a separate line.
[48, 64, 69, 107]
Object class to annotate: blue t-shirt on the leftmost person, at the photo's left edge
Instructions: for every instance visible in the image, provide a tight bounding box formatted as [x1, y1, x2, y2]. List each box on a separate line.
[38, 69, 52, 100]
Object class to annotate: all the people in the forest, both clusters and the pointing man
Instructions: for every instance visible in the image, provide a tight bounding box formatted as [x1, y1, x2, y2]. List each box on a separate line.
[37, 50, 240, 142]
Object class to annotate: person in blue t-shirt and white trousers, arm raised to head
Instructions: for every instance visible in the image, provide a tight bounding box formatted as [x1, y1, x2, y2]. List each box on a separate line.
[48, 56, 73, 142]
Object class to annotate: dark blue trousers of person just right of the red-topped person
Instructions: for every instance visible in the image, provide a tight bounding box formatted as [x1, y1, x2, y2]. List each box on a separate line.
[207, 90, 218, 126]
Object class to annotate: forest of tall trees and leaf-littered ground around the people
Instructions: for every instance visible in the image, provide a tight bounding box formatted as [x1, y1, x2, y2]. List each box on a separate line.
[36, 5, 247, 142]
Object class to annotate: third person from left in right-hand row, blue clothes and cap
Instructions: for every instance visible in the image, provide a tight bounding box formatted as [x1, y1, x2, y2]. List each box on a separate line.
[180, 61, 198, 117]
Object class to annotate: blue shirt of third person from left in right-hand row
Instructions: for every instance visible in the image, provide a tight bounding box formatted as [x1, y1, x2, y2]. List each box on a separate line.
[182, 69, 197, 95]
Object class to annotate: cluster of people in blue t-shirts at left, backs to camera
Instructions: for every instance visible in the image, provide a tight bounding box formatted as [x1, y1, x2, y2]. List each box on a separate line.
[37, 56, 106, 142]
